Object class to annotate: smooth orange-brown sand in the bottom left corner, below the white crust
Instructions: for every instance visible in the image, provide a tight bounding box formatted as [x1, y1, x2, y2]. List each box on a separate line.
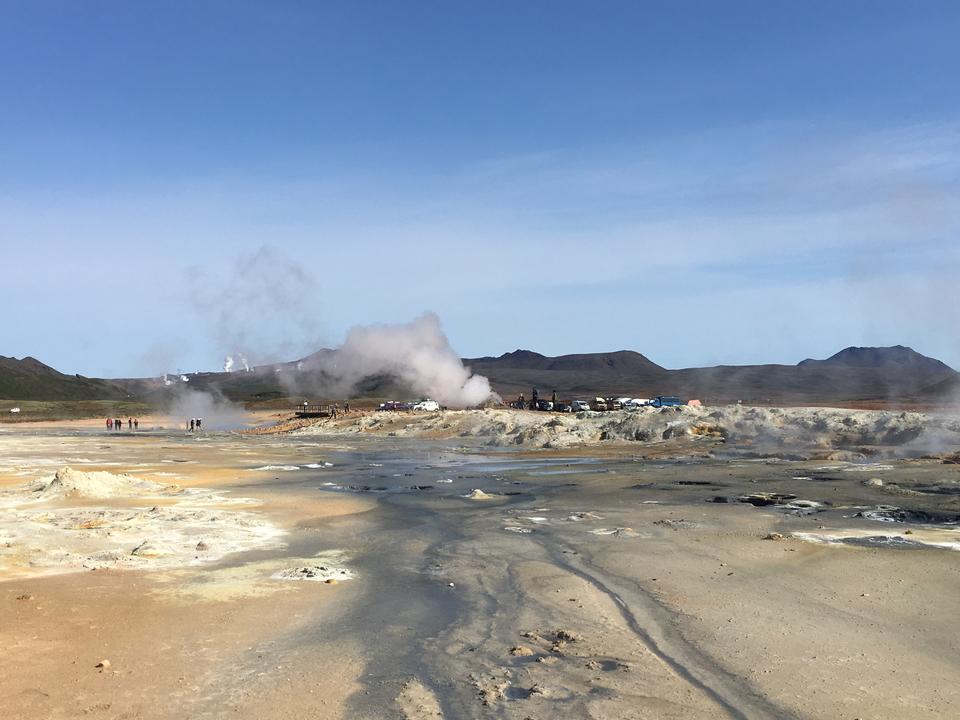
[0, 571, 368, 718]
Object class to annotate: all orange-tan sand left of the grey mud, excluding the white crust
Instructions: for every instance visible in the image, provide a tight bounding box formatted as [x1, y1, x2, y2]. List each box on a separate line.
[0, 423, 371, 718]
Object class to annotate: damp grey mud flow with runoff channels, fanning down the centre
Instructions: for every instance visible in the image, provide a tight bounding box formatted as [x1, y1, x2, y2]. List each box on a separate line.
[221, 430, 960, 718]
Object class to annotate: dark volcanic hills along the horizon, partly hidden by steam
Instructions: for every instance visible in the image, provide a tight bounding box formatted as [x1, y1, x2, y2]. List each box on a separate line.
[0, 345, 960, 404]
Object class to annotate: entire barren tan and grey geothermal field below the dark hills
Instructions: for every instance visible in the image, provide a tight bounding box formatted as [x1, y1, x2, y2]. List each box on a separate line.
[0, 409, 960, 720]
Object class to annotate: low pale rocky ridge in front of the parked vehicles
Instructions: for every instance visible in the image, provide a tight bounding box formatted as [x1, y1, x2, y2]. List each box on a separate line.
[297, 405, 960, 459]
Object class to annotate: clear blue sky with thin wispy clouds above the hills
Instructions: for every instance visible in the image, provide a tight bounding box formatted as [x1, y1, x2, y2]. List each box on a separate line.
[0, 0, 960, 376]
